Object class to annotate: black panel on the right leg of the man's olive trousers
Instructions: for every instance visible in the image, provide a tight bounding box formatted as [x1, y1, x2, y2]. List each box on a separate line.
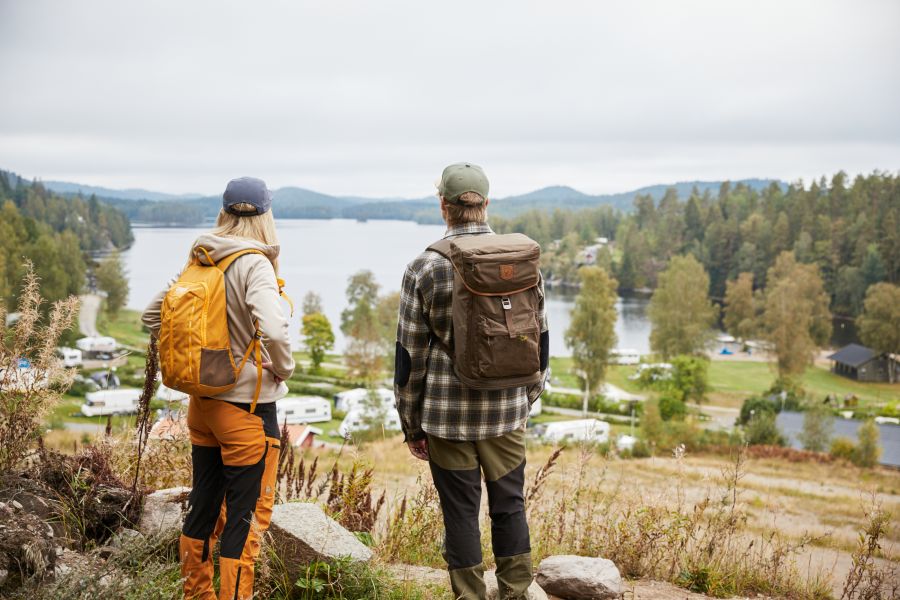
[485, 461, 531, 556]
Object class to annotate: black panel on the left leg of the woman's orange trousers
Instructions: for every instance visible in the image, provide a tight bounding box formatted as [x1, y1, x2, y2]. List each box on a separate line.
[181, 446, 225, 540]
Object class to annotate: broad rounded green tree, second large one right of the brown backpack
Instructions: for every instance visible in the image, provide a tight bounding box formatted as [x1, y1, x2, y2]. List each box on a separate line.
[648, 255, 718, 358]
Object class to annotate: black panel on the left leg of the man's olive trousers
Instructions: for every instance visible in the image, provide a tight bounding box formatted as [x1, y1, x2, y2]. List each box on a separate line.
[430, 461, 481, 570]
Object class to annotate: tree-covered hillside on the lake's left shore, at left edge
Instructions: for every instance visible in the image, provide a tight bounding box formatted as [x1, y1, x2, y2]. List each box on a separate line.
[0, 171, 133, 310]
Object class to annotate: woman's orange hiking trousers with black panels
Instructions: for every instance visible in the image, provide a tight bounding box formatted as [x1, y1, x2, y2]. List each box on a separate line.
[179, 396, 281, 600]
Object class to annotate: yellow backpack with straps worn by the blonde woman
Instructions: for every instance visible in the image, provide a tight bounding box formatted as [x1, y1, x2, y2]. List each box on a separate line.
[159, 247, 293, 412]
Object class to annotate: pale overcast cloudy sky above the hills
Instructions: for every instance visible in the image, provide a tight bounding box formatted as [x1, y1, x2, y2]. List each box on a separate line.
[0, 0, 900, 197]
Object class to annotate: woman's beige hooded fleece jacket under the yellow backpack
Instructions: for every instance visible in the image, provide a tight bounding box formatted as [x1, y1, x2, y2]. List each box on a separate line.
[141, 233, 294, 404]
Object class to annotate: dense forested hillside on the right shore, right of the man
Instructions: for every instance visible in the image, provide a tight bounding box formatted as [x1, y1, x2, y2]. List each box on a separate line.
[491, 173, 900, 315]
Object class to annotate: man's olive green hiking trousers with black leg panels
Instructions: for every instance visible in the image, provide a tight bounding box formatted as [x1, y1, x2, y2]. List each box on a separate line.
[428, 429, 532, 600]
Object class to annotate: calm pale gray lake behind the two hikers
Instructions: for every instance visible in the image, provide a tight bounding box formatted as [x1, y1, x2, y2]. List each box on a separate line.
[123, 219, 650, 356]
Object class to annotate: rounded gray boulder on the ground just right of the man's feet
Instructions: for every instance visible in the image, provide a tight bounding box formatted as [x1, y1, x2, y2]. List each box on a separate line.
[535, 555, 625, 600]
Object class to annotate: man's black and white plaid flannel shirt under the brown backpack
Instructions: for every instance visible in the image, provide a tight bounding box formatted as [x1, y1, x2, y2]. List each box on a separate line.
[394, 223, 547, 441]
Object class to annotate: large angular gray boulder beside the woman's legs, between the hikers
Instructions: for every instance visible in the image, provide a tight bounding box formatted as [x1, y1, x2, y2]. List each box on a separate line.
[269, 502, 372, 574]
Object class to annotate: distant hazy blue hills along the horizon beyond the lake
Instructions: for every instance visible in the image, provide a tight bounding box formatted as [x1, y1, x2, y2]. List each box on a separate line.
[15, 173, 787, 225]
